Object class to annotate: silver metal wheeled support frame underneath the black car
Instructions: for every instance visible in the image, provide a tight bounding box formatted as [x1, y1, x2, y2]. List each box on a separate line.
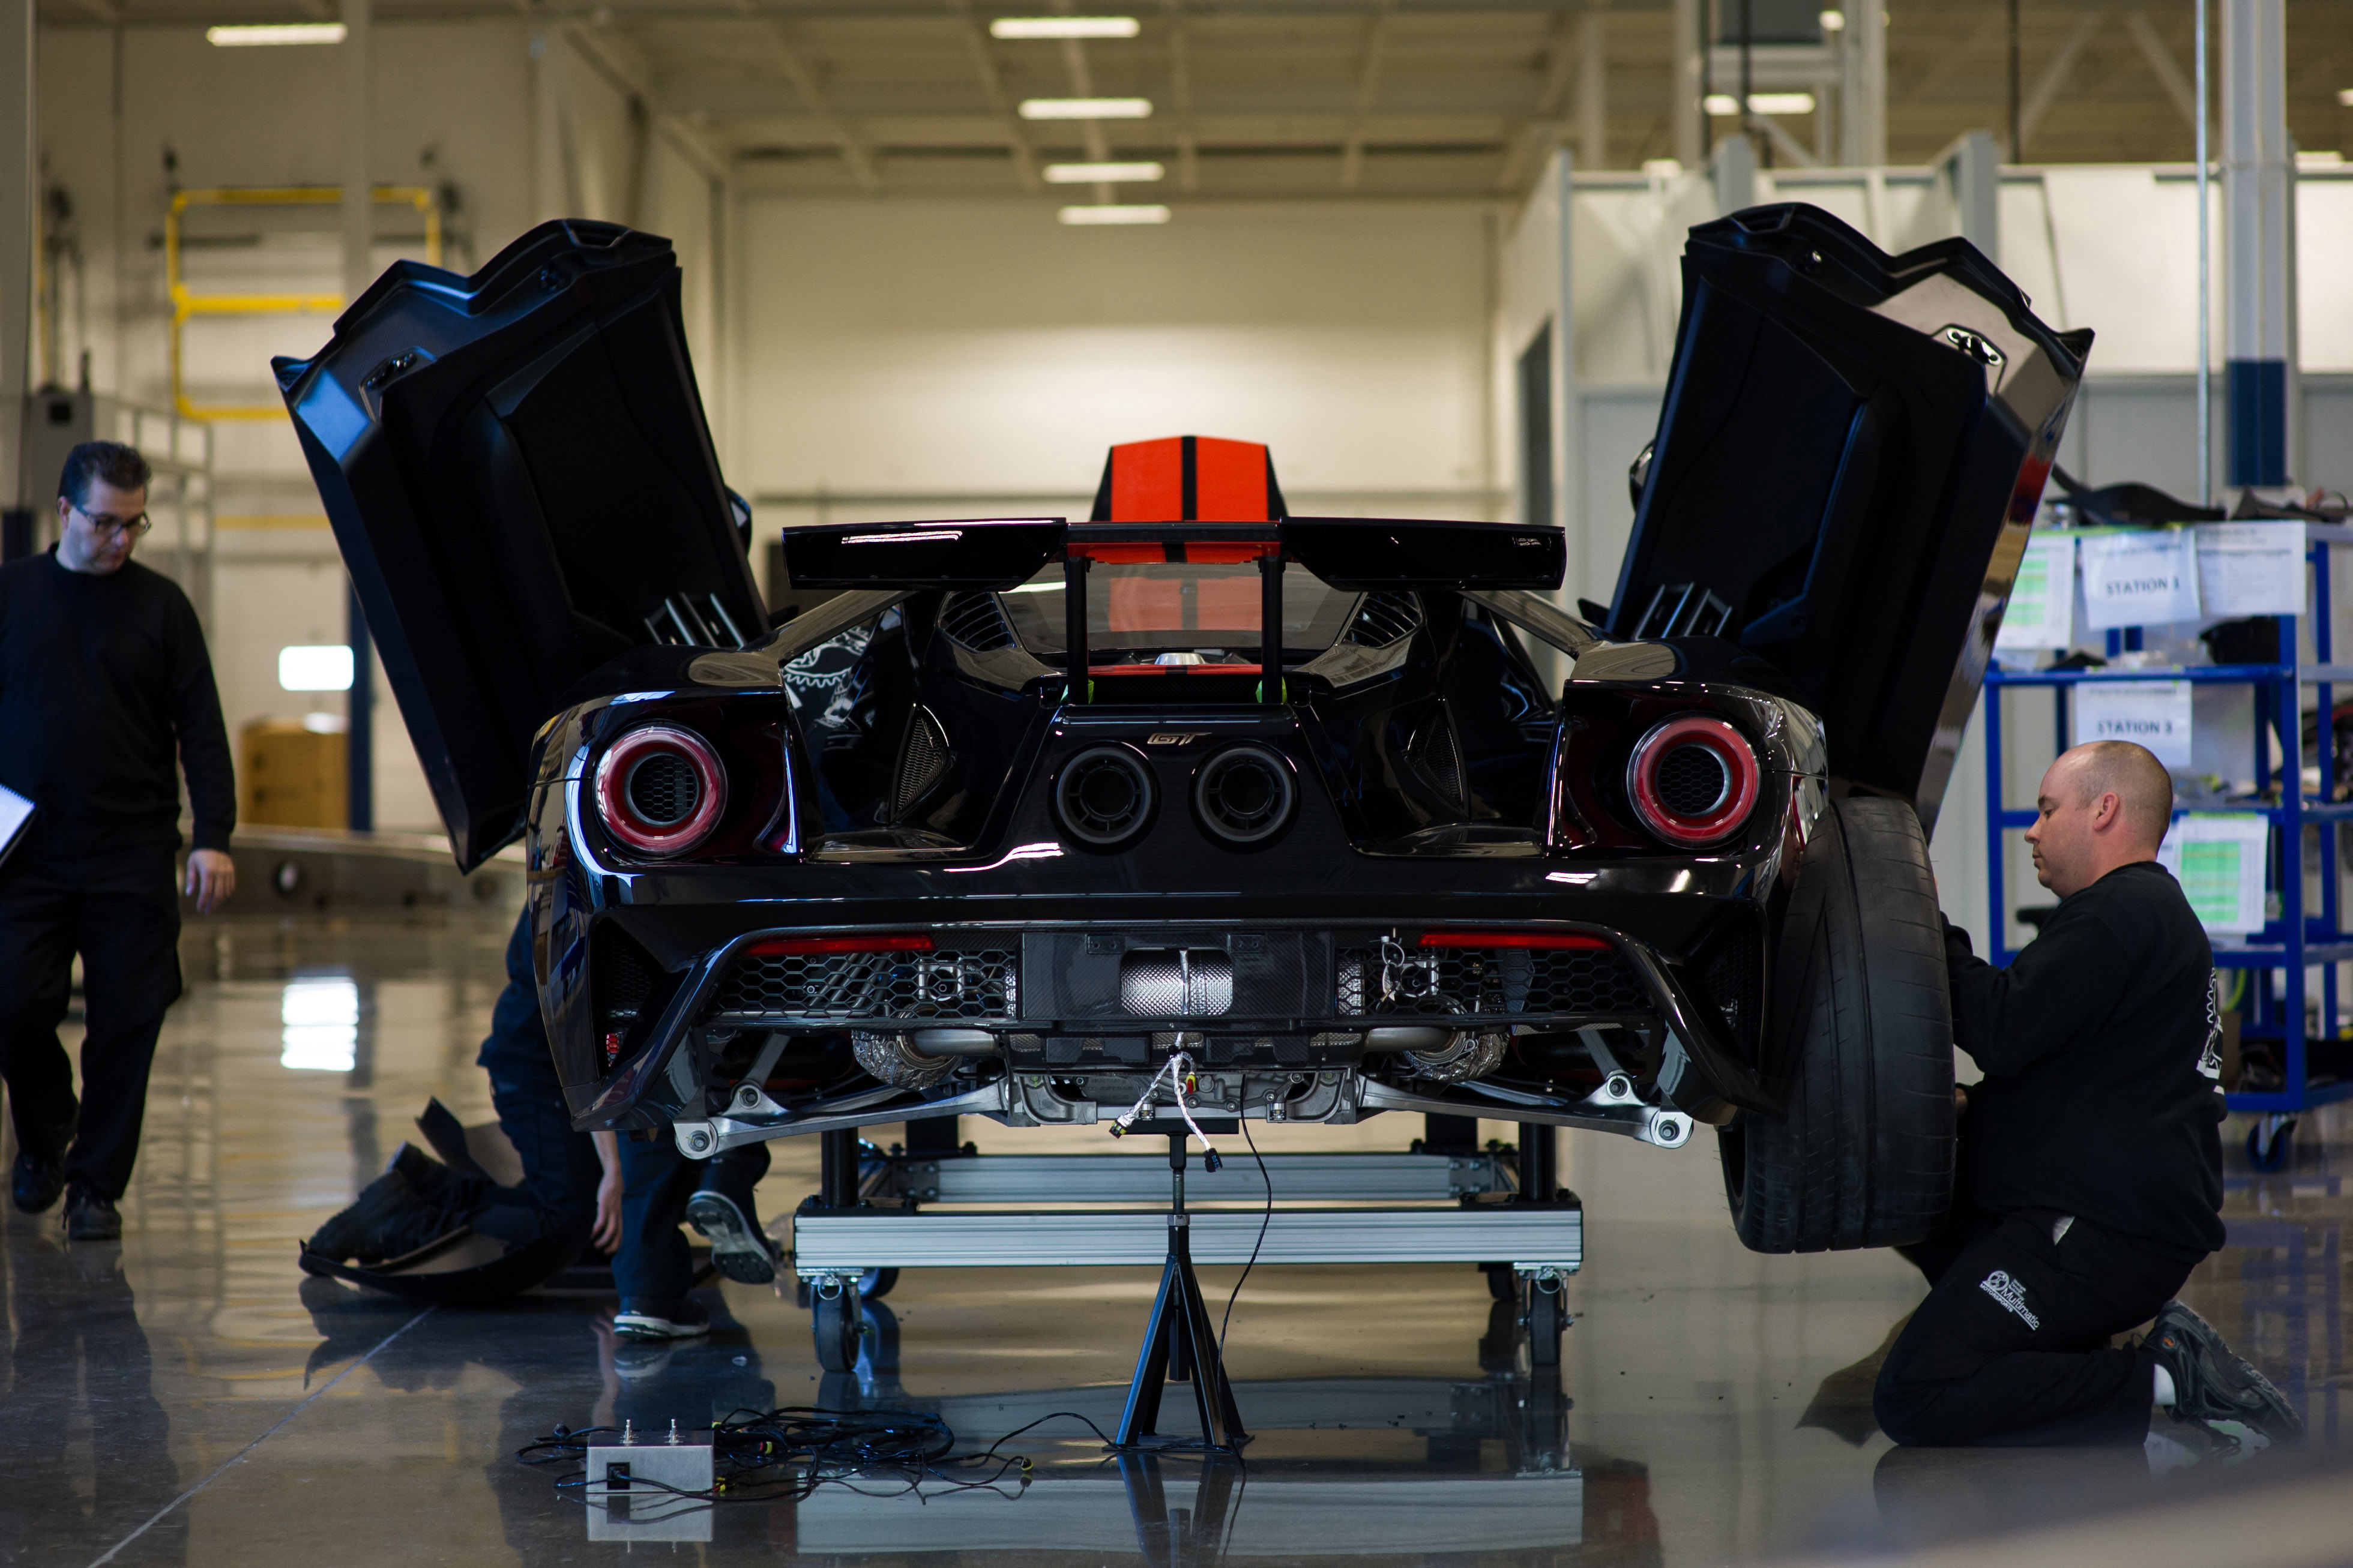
[791, 1117, 1583, 1371]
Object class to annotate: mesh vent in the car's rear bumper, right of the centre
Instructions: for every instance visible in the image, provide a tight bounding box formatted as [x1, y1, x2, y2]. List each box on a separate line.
[1339, 948, 1652, 1018]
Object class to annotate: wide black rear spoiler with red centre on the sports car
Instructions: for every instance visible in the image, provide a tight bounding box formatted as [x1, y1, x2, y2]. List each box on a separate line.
[783, 517, 1567, 592]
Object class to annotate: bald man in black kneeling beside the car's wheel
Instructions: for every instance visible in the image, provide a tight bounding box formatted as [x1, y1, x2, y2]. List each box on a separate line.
[1873, 740, 2304, 1446]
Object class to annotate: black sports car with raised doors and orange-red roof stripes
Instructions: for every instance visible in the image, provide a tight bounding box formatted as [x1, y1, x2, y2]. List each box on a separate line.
[278, 205, 2089, 1251]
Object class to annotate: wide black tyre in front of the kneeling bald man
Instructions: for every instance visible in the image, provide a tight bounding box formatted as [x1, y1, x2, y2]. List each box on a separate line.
[1718, 797, 1953, 1253]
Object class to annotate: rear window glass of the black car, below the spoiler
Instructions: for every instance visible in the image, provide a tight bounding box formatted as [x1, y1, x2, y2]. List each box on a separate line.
[1000, 562, 1363, 663]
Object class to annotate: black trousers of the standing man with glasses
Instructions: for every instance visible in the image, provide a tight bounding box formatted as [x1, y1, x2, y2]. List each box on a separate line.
[0, 844, 179, 1201]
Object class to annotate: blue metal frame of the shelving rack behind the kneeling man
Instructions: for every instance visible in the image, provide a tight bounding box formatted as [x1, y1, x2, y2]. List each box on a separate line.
[1986, 522, 2353, 1171]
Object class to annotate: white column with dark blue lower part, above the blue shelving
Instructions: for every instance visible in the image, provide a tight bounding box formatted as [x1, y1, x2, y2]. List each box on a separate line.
[2200, 0, 2297, 484]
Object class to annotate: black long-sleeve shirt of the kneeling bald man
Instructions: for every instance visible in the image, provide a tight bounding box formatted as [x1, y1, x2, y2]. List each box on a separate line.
[1944, 861, 2223, 1260]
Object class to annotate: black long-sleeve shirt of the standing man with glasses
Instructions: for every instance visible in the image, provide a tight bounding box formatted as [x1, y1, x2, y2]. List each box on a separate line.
[0, 550, 238, 858]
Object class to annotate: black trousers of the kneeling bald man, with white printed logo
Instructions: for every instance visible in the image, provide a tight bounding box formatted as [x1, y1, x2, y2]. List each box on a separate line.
[1870, 1199, 2193, 1446]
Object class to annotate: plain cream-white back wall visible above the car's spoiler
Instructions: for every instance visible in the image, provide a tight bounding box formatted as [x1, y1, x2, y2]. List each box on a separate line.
[729, 195, 1494, 531]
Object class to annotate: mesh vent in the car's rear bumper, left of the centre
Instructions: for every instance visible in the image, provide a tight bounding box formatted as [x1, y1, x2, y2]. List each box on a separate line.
[708, 950, 1016, 1023]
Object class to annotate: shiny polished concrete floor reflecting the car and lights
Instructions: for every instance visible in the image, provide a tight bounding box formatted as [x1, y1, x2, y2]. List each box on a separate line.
[0, 915, 2353, 1568]
